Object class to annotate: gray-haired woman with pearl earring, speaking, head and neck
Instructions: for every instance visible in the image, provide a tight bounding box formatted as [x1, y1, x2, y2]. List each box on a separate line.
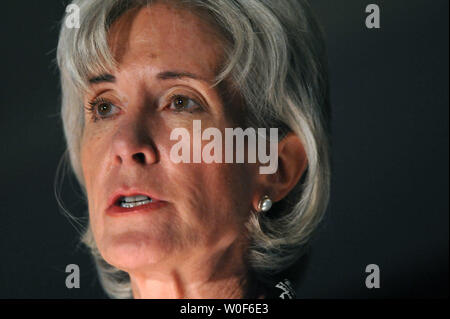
[57, 0, 329, 298]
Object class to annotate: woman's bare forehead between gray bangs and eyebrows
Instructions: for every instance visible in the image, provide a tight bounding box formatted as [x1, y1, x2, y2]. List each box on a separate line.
[108, 3, 223, 78]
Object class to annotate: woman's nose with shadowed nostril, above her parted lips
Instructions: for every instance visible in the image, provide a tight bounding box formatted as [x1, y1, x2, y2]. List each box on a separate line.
[112, 121, 157, 165]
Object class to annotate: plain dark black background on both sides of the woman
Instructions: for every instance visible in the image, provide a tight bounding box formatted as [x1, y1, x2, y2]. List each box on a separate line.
[0, 0, 449, 298]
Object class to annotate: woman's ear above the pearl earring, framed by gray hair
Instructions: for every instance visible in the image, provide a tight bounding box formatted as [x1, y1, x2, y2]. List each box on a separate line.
[255, 132, 308, 205]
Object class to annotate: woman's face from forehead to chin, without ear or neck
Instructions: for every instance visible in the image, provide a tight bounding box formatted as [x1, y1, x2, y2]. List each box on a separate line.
[81, 4, 257, 271]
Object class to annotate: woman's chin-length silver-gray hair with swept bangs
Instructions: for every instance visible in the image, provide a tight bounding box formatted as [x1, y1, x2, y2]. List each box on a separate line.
[57, 0, 330, 298]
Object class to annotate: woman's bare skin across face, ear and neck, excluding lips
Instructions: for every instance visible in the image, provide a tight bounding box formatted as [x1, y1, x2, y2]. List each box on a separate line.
[81, 3, 306, 298]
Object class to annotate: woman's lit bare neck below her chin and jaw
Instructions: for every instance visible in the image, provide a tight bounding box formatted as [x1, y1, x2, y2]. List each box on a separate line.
[129, 241, 250, 299]
